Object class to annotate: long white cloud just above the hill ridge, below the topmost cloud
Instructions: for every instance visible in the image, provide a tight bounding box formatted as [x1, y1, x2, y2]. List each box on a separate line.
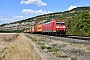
[22, 9, 52, 15]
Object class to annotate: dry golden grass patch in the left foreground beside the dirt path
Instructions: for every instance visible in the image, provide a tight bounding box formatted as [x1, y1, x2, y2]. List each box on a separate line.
[0, 34, 44, 60]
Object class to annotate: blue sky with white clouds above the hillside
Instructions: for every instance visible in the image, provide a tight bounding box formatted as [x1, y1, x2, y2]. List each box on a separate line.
[0, 0, 90, 24]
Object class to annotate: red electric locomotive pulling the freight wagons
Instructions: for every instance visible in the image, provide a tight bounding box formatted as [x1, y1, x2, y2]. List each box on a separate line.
[42, 20, 66, 35]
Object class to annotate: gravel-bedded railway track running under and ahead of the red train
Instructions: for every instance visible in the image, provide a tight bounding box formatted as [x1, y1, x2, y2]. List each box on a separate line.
[33, 34, 90, 45]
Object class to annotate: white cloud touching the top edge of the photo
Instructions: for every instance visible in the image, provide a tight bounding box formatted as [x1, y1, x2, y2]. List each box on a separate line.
[20, 0, 47, 6]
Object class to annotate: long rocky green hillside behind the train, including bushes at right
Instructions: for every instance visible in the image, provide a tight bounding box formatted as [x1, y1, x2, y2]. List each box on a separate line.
[0, 6, 90, 36]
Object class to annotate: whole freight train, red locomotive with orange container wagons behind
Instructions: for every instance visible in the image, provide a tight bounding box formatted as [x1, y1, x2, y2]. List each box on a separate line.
[24, 20, 66, 35]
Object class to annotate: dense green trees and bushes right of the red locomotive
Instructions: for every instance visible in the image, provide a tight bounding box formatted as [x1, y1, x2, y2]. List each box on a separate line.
[67, 11, 90, 36]
